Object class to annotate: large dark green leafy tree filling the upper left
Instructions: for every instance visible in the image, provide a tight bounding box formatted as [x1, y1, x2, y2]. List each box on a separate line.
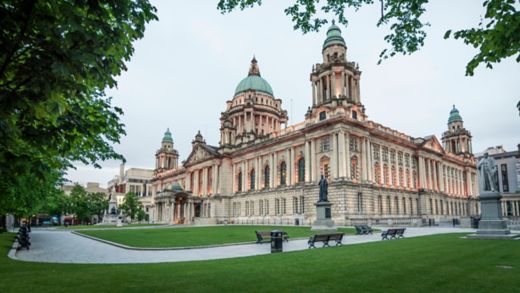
[0, 0, 157, 218]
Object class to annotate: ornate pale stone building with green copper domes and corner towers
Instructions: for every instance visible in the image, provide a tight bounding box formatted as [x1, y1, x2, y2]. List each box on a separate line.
[152, 25, 478, 225]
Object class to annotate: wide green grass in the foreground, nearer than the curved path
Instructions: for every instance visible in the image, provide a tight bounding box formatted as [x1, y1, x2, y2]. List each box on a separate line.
[0, 233, 520, 293]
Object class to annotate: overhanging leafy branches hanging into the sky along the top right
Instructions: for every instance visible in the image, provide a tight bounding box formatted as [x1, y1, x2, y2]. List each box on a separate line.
[217, 0, 520, 75]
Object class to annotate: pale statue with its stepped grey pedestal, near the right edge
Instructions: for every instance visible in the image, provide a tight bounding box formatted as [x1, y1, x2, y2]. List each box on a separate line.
[470, 153, 519, 239]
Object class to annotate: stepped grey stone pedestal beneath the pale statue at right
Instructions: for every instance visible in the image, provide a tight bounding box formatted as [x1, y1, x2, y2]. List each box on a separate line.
[470, 192, 520, 239]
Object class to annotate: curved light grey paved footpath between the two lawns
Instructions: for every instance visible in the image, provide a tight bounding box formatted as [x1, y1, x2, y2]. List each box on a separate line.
[9, 227, 475, 264]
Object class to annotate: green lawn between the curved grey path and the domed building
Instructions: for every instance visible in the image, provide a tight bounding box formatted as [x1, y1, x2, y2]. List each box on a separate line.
[81, 225, 355, 247]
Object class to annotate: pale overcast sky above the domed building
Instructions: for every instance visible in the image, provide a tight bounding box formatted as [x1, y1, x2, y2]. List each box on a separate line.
[67, 0, 520, 186]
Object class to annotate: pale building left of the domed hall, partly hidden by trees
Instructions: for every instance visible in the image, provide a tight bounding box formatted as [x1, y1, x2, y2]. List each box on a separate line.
[107, 164, 154, 213]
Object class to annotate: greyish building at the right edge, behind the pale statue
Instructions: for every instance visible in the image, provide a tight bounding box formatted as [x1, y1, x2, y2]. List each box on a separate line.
[478, 144, 520, 219]
